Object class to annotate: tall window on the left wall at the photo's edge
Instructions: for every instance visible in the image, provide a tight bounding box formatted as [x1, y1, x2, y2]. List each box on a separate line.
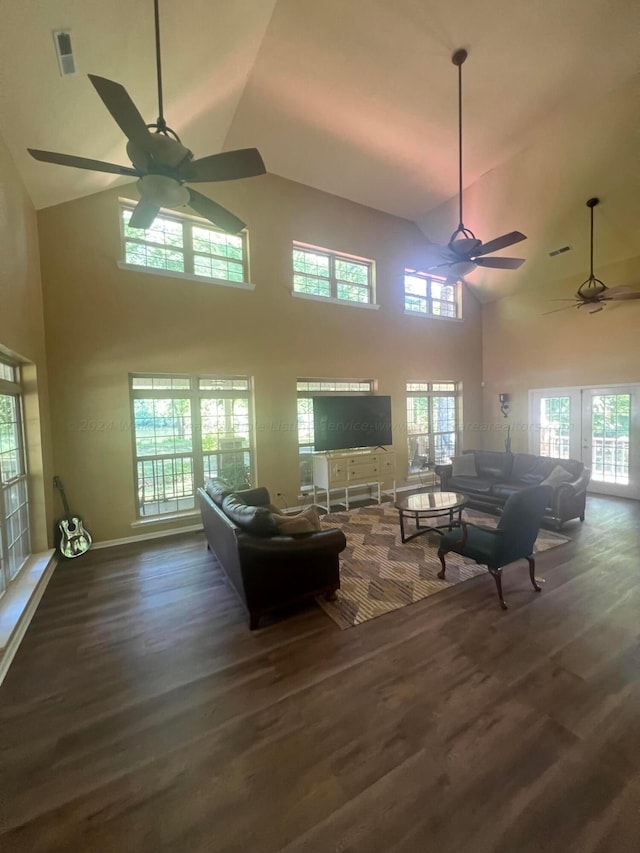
[0, 361, 31, 594]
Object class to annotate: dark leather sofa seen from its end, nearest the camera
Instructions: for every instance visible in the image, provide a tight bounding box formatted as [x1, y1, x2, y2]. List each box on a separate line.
[198, 480, 346, 630]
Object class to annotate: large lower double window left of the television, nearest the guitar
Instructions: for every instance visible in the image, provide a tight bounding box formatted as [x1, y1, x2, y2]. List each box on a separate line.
[131, 375, 253, 518]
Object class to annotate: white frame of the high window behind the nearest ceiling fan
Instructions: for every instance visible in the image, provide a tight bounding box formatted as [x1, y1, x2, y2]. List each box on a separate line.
[118, 199, 255, 290]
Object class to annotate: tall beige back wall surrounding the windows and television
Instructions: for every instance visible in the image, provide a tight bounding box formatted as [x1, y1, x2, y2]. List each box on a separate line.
[38, 175, 482, 540]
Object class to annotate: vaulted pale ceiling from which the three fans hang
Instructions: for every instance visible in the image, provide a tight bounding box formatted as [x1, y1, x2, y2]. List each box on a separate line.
[0, 0, 640, 298]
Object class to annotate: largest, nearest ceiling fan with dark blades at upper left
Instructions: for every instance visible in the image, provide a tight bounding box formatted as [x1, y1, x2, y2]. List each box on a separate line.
[27, 0, 266, 234]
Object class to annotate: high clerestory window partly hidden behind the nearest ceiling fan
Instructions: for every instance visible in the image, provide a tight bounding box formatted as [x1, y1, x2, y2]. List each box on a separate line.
[120, 201, 249, 284]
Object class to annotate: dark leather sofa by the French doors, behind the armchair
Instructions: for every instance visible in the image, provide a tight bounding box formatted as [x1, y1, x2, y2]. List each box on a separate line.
[435, 450, 591, 529]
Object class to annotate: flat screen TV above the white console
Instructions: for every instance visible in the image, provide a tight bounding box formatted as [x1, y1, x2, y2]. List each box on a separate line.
[313, 396, 392, 451]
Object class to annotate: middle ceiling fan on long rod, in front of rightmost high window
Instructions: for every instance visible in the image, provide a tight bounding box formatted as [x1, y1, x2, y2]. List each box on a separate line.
[429, 48, 527, 284]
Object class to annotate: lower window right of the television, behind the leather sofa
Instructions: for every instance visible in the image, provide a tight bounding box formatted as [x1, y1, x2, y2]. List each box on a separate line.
[407, 382, 458, 474]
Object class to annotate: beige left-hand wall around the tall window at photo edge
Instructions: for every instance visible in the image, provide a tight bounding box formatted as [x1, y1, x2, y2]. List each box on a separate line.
[0, 130, 52, 551]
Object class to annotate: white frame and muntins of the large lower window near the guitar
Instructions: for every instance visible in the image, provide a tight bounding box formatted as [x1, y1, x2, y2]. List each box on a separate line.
[129, 373, 255, 520]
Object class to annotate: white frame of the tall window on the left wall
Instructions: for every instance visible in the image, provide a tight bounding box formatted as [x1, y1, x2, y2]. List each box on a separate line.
[0, 359, 31, 596]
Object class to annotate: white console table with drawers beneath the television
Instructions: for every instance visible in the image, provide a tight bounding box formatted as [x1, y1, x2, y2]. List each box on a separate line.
[313, 448, 396, 512]
